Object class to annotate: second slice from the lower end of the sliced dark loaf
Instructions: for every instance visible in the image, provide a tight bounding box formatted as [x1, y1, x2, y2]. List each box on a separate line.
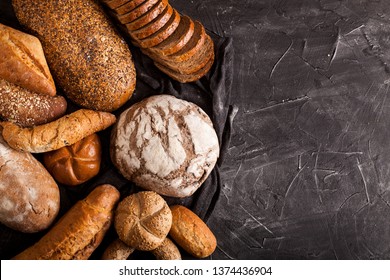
[142, 35, 214, 74]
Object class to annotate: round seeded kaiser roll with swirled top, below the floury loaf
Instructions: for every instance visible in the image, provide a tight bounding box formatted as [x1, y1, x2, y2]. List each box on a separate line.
[114, 191, 172, 251]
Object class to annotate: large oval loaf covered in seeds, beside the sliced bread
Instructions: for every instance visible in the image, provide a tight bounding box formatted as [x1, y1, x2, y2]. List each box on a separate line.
[12, 0, 136, 111]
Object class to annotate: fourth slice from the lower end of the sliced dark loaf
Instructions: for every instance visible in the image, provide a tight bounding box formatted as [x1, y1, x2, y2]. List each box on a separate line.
[150, 15, 194, 56]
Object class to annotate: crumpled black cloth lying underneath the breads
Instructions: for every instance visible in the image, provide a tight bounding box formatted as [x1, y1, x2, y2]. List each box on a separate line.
[0, 1, 234, 259]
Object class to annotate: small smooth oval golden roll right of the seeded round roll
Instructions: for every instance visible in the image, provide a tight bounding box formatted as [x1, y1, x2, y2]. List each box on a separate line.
[169, 205, 217, 258]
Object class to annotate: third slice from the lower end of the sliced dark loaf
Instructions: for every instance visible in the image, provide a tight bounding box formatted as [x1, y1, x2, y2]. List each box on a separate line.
[169, 21, 207, 62]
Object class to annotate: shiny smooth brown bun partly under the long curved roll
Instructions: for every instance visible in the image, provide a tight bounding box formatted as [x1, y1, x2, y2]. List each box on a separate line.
[43, 133, 102, 186]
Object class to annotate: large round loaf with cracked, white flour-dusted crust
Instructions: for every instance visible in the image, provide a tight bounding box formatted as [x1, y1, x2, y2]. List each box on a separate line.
[110, 95, 219, 197]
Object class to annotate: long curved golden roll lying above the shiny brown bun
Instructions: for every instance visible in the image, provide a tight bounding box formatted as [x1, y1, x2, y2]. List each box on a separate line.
[1, 109, 115, 153]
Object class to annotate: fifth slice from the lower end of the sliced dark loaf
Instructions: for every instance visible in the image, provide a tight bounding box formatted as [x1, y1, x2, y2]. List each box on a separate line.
[129, 9, 180, 48]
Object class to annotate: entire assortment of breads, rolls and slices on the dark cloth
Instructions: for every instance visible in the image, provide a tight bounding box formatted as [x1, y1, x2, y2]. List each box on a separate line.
[0, 0, 219, 259]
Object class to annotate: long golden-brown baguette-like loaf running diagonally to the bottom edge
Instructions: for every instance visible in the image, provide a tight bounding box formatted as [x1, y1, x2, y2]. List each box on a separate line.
[13, 185, 119, 260]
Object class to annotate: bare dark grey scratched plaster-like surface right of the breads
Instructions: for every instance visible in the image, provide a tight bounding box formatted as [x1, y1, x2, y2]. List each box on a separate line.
[2, 0, 390, 259]
